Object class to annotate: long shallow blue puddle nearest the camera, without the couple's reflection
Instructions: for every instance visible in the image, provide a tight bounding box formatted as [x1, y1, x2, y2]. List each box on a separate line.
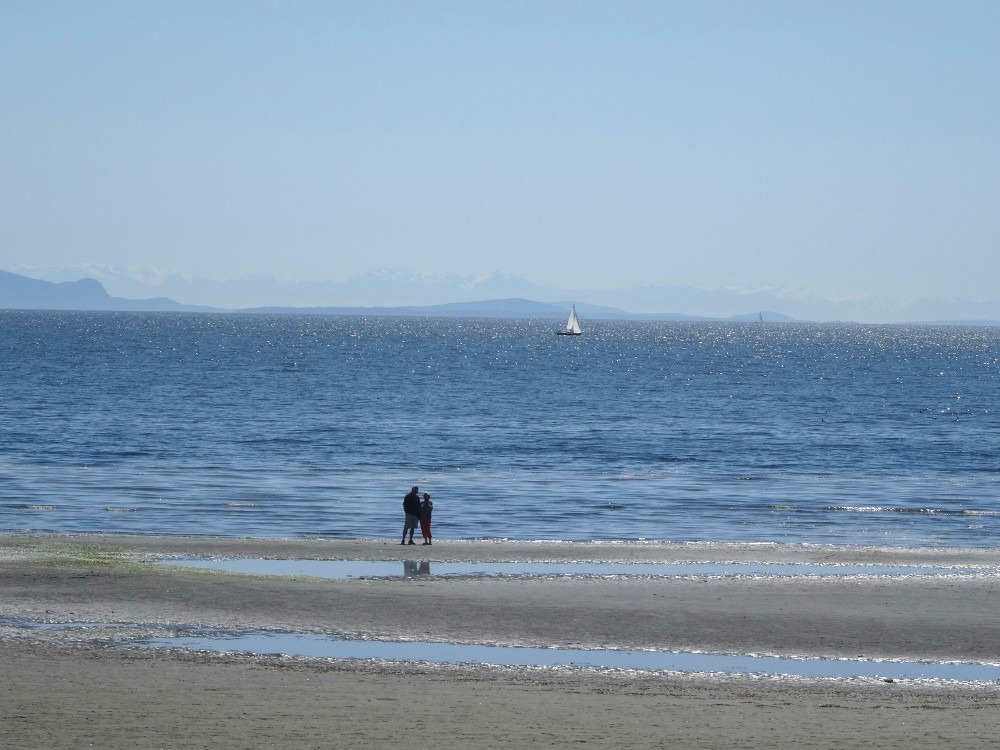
[131, 632, 1000, 682]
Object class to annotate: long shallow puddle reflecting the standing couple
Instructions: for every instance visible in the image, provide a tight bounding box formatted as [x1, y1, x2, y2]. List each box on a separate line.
[160, 558, 996, 579]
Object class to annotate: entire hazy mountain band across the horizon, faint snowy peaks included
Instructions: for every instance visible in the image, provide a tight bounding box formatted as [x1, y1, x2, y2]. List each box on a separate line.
[0, 268, 1000, 325]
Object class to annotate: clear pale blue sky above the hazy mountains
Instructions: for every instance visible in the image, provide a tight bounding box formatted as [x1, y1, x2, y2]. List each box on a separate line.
[0, 0, 1000, 314]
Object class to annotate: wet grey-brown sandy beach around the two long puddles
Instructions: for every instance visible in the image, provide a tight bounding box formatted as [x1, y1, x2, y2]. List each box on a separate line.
[0, 535, 1000, 748]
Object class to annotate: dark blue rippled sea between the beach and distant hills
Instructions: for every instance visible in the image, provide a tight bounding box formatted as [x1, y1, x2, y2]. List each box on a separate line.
[0, 311, 1000, 547]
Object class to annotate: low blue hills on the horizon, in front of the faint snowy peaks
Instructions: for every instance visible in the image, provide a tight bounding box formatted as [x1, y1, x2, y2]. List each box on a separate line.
[0, 271, 791, 322]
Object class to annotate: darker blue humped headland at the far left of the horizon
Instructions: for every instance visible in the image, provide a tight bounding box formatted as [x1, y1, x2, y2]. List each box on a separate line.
[0, 271, 218, 312]
